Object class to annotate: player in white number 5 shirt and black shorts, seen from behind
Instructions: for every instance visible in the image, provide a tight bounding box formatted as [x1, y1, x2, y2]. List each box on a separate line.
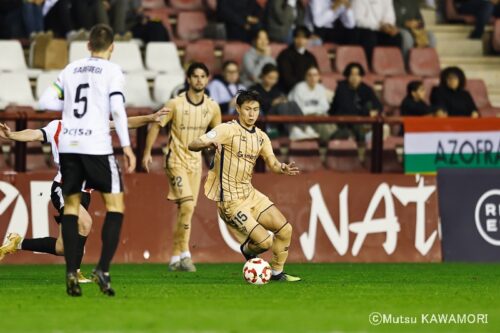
[42, 24, 136, 296]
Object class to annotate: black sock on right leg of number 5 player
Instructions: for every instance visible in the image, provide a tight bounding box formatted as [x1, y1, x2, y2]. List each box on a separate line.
[97, 212, 123, 272]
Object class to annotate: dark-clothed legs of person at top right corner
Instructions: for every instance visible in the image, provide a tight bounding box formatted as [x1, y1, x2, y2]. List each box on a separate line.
[455, 0, 500, 39]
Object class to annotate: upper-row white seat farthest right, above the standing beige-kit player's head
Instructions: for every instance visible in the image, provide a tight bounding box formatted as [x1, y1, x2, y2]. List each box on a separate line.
[146, 42, 184, 75]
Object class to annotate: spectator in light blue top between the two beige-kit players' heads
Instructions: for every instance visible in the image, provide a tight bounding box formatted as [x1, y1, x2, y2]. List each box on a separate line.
[207, 60, 245, 114]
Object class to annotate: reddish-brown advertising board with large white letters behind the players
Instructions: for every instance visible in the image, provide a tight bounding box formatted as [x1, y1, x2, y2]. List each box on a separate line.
[0, 171, 441, 263]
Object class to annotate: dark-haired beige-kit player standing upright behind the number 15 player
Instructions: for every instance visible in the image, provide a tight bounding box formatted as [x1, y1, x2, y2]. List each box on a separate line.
[142, 63, 221, 272]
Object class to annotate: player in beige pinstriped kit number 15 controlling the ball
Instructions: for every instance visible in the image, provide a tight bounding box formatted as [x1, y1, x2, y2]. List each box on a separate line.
[189, 91, 300, 282]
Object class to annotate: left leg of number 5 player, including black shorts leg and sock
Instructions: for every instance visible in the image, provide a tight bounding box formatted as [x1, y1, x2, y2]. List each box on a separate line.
[59, 154, 84, 296]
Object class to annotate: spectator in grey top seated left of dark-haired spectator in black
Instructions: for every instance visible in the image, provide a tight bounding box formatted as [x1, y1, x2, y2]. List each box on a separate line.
[241, 29, 276, 87]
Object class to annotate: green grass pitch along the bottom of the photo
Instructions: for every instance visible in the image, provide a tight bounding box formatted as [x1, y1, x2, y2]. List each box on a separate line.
[0, 263, 500, 333]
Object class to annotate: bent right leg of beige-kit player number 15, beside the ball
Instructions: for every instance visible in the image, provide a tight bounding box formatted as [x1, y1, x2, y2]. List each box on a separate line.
[258, 205, 300, 282]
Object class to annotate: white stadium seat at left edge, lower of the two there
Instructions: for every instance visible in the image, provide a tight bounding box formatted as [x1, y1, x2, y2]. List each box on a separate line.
[0, 73, 36, 110]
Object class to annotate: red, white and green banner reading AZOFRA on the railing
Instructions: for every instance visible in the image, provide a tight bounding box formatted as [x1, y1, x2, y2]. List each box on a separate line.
[404, 117, 500, 174]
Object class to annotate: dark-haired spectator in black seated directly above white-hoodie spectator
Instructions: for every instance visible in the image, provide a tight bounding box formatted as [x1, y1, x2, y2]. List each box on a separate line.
[278, 26, 318, 93]
